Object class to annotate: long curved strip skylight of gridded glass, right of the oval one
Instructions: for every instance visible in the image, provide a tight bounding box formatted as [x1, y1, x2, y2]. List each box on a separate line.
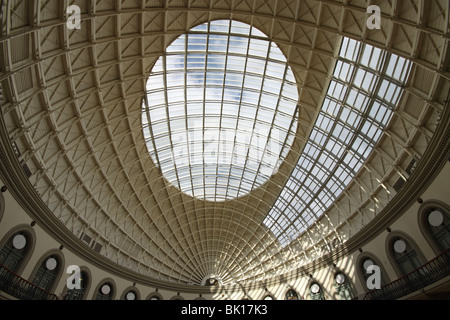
[264, 38, 410, 246]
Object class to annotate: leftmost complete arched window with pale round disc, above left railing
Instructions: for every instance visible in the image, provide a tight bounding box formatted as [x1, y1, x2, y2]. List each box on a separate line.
[0, 231, 29, 273]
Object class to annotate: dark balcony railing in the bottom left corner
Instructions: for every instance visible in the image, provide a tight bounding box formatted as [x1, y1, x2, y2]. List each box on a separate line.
[0, 265, 58, 300]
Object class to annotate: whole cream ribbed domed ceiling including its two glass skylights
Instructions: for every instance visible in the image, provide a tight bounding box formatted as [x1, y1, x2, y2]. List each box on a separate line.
[0, 0, 450, 285]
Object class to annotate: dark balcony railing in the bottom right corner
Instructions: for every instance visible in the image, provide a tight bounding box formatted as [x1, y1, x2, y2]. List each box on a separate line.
[364, 248, 450, 300]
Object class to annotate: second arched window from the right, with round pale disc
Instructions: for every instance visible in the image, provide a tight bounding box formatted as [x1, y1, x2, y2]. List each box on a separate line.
[390, 236, 422, 276]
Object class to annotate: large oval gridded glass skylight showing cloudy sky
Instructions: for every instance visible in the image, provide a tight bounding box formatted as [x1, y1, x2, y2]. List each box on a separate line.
[142, 20, 298, 201]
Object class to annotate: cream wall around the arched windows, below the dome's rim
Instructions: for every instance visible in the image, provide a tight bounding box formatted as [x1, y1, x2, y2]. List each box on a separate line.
[0, 162, 450, 300]
